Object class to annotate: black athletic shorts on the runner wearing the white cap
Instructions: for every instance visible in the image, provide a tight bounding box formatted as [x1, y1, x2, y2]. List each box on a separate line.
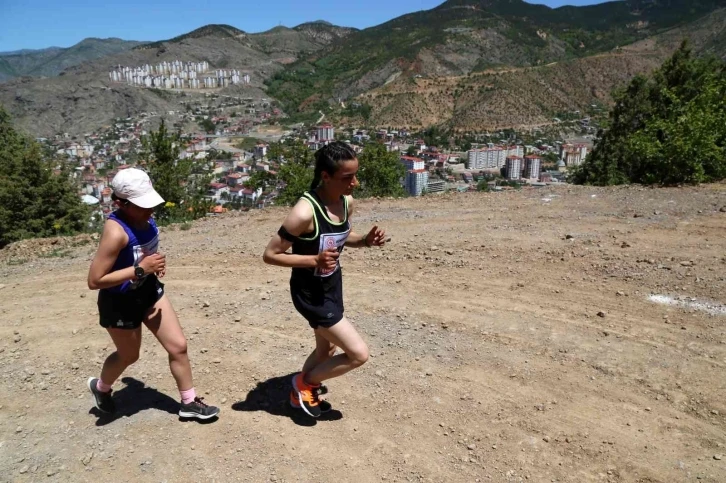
[98, 275, 164, 329]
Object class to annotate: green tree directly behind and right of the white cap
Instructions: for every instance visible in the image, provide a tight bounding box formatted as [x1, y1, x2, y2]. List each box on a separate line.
[140, 119, 212, 224]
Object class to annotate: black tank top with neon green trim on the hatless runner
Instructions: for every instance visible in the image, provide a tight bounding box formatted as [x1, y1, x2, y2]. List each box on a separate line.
[292, 191, 350, 283]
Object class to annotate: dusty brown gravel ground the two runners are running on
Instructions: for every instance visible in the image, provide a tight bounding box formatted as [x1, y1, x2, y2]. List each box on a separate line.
[0, 185, 726, 483]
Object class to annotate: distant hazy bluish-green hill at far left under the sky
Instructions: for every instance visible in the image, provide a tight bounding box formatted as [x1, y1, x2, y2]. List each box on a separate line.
[0, 38, 142, 82]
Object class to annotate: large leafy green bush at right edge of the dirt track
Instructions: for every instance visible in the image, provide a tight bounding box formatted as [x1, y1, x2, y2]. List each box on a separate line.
[570, 43, 726, 185]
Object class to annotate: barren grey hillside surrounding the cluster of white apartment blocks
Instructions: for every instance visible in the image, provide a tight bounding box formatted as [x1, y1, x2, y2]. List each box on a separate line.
[0, 23, 358, 136]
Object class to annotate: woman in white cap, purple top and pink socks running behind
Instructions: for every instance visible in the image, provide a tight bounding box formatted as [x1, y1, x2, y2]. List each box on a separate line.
[88, 168, 219, 419]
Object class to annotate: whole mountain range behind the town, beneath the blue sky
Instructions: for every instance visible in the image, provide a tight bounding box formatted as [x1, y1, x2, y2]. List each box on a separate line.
[0, 0, 726, 135]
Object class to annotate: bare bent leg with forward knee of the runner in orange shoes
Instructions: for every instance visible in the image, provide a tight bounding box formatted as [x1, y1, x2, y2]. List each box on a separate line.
[305, 317, 368, 385]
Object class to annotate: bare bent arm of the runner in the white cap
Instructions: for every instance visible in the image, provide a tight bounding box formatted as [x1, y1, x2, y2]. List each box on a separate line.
[88, 221, 166, 290]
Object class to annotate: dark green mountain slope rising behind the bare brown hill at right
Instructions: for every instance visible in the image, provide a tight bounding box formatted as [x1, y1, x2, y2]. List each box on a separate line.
[269, 0, 726, 120]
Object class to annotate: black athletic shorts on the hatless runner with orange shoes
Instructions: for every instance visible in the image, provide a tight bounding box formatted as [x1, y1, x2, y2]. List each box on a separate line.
[290, 270, 345, 329]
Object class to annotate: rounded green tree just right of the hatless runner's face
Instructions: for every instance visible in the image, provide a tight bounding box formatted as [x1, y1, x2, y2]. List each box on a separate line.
[357, 142, 406, 198]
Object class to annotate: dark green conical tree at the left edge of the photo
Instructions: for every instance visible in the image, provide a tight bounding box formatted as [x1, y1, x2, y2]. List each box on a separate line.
[0, 106, 90, 248]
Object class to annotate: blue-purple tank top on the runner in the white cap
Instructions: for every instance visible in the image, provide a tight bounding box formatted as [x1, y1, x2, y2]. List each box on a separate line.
[102, 211, 159, 293]
